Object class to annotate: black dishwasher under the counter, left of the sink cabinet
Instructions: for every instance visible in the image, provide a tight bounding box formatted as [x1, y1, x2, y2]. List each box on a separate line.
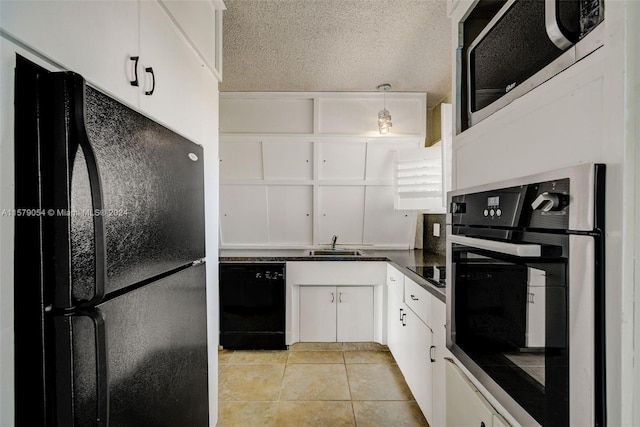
[219, 263, 286, 349]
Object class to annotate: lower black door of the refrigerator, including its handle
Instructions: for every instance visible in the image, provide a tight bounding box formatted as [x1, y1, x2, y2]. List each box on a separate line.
[56, 264, 208, 427]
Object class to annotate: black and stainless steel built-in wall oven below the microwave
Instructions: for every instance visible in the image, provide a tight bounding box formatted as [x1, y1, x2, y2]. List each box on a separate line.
[447, 165, 605, 426]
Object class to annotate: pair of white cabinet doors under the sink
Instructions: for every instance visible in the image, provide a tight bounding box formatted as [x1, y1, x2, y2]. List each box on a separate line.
[300, 286, 374, 342]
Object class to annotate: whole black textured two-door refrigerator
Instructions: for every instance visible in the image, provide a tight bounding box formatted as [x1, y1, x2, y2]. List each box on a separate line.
[14, 57, 208, 427]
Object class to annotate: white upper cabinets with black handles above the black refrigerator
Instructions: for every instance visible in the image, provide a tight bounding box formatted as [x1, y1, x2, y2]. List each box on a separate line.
[1, 0, 222, 143]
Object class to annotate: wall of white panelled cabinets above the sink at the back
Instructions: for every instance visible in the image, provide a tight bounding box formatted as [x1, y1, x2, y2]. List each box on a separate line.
[220, 92, 426, 249]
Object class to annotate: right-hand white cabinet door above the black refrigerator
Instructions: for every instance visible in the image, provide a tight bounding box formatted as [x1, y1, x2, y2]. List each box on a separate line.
[139, 1, 204, 141]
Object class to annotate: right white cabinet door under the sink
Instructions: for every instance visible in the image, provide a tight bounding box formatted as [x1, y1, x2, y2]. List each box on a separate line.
[337, 286, 373, 342]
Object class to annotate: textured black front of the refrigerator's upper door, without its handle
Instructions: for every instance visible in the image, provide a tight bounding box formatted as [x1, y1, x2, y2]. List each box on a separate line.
[71, 87, 204, 301]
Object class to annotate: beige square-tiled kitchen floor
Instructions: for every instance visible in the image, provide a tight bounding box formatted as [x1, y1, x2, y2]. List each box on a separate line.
[217, 343, 428, 427]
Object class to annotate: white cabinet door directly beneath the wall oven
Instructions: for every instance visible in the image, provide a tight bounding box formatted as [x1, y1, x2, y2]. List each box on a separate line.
[445, 361, 494, 427]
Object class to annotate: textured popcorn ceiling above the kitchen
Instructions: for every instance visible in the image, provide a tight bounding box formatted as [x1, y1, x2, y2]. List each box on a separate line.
[220, 0, 451, 108]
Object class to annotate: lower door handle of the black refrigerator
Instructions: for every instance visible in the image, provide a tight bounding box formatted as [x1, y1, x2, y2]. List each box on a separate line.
[77, 309, 109, 427]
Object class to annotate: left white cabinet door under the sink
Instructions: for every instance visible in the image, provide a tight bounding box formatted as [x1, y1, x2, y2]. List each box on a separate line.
[300, 286, 337, 342]
